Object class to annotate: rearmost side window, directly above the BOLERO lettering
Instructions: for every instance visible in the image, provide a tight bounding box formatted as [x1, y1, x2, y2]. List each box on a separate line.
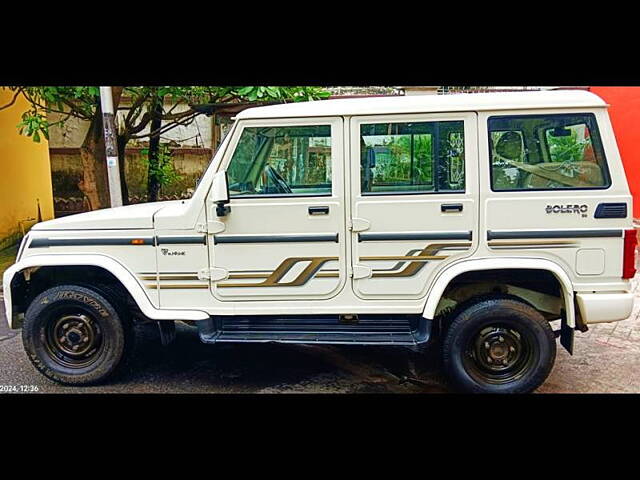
[489, 113, 611, 191]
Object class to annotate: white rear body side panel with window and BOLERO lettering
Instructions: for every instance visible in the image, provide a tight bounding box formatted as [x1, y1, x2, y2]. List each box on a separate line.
[479, 108, 631, 284]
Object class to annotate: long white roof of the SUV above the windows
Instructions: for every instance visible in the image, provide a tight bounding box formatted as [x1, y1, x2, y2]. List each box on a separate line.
[236, 90, 607, 119]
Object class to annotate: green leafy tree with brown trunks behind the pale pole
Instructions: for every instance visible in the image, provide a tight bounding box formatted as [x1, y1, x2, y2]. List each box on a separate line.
[0, 86, 329, 209]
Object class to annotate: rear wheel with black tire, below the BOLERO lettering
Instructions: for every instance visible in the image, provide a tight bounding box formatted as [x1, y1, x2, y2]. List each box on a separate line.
[442, 296, 556, 393]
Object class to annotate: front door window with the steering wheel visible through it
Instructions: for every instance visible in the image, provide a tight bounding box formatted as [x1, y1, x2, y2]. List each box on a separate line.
[227, 125, 331, 197]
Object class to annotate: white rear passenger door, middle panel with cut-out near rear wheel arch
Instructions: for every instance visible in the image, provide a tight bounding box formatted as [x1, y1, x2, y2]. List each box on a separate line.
[350, 113, 478, 299]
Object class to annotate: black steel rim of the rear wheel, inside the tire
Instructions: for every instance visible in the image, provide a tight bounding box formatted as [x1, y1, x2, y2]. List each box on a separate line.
[463, 322, 537, 385]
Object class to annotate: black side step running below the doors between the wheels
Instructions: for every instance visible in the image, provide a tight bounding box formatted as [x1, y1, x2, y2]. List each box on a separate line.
[198, 316, 431, 345]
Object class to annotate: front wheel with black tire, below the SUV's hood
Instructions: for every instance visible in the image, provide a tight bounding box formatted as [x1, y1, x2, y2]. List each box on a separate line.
[22, 285, 135, 385]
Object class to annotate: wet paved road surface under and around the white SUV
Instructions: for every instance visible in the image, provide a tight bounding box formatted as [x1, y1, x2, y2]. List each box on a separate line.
[0, 282, 640, 393]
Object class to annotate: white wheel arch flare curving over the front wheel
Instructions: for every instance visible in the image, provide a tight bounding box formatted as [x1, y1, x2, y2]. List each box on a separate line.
[2, 254, 209, 328]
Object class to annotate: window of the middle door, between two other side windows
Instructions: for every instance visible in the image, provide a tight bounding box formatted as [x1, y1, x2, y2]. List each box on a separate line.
[360, 121, 464, 195]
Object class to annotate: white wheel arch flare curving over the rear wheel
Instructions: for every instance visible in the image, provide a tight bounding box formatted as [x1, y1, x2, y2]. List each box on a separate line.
[422, 258, 576, 328]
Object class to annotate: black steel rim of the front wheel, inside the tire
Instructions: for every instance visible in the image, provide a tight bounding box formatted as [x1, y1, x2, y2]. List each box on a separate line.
[44, 308, 104, 368]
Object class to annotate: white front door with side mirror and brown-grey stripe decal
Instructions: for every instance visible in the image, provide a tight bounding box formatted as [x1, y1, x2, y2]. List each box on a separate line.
[207, 118, 347, 301]
